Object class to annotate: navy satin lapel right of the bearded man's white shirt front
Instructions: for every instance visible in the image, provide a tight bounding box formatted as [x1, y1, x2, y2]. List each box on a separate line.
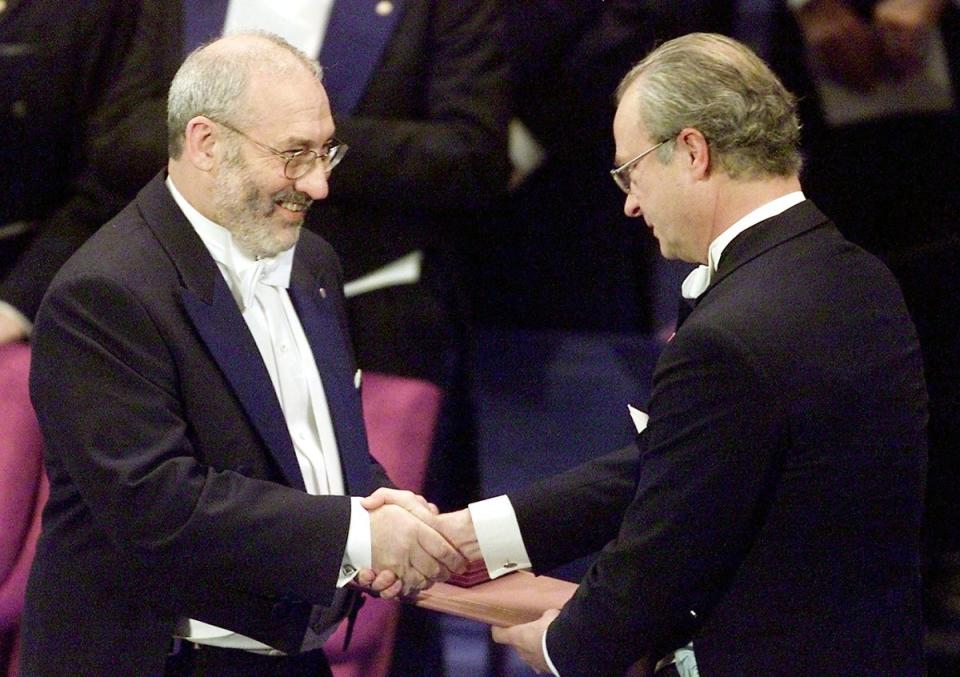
[290, 282, 376, 496]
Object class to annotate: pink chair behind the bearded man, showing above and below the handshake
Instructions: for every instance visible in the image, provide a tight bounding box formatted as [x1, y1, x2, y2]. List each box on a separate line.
[325, 372, 443, 677]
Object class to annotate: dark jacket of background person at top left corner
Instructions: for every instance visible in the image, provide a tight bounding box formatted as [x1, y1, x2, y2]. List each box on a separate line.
[0, 0, 142, 320]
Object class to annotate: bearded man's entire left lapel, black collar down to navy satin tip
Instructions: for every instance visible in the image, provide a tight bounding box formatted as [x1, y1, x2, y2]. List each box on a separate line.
[137, 173, 305, 490]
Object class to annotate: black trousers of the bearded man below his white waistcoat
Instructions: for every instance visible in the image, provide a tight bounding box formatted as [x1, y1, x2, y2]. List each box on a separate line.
[164, 642, 333, 677]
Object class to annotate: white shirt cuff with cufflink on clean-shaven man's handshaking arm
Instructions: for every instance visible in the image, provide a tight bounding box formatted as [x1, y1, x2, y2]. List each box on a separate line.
[467, 496, 531, 578]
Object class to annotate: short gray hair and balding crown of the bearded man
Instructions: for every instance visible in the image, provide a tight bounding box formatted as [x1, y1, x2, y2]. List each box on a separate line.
[167, 31, 323, 159]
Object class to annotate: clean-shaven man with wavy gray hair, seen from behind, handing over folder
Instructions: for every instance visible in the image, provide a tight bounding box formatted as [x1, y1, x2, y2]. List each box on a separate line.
[392, 34, 927, 677]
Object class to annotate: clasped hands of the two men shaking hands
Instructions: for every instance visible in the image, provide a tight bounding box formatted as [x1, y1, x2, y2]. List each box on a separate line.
[355, 489, 481, 599]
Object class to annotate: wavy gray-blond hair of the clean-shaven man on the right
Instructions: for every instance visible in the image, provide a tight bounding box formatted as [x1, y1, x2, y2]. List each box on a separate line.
[617, 33, 802, 179]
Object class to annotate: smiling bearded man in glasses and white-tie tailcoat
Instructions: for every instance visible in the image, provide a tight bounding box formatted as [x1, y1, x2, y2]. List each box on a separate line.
[22, 33, 463, 675]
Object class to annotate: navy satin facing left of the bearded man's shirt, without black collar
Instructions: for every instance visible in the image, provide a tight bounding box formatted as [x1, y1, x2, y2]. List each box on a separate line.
[180, 271, 305, 490]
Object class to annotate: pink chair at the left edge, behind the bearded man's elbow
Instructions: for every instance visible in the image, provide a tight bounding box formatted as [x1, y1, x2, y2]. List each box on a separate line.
[0, 343, 48, 677]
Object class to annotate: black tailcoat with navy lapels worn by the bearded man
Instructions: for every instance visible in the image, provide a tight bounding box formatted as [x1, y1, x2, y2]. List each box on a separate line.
[22, 174, 383, 675]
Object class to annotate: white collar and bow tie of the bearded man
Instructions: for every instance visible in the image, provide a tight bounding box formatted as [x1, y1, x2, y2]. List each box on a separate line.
[166, 176, 296, 310]
